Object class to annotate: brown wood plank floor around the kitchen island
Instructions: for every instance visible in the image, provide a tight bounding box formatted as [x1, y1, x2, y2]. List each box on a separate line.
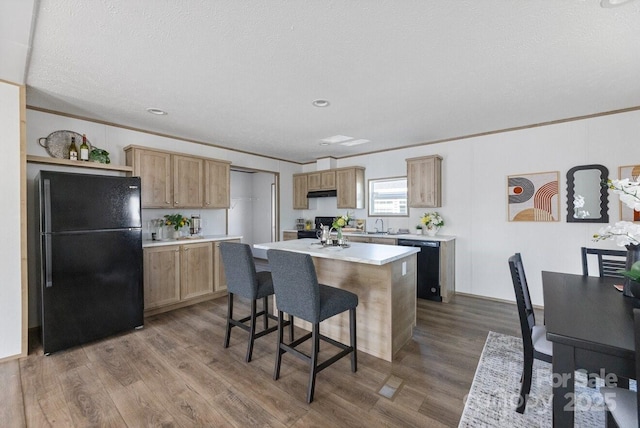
[0, 280, 528, 427]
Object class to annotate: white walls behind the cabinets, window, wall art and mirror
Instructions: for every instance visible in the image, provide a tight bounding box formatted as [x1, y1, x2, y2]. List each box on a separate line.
[27, 110, 640, 316]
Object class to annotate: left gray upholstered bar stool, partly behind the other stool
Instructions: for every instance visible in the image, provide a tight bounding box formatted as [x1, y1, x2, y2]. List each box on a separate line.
[220, 242, 293, 362]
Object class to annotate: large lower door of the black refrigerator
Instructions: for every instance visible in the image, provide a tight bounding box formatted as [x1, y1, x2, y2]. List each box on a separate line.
[41, 229, 143, 354]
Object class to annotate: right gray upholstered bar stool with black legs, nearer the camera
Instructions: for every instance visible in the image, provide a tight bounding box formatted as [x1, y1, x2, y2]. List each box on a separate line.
[267, 250, 358, 403]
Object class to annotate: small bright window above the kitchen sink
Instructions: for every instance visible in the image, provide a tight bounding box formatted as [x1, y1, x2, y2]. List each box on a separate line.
[369, 177, 409, 216]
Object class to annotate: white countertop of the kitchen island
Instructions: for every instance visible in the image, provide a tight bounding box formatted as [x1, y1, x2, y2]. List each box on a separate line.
[253, 239, 420, 266]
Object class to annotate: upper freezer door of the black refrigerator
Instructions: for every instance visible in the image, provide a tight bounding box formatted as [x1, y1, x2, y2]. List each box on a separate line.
[38, 171, 142, 233]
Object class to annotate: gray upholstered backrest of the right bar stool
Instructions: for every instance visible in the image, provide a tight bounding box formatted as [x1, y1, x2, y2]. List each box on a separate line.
[267, 250, 320, 323]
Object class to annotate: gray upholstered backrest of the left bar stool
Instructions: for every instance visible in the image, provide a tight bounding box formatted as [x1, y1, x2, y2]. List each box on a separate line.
[220, 242, 258, 299]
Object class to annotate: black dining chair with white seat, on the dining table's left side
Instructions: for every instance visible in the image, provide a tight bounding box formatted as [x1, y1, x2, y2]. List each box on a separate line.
[509, 253, 553, 413]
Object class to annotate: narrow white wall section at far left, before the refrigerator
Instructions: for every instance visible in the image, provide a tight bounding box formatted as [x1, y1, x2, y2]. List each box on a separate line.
[0, 81, 26, 360]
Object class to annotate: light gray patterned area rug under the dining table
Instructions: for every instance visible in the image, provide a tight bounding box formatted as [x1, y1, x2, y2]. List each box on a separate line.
[459, 332, 605, 427]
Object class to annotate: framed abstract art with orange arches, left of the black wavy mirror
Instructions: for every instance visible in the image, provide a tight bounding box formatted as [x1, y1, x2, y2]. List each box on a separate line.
[507, 171, 560, 221]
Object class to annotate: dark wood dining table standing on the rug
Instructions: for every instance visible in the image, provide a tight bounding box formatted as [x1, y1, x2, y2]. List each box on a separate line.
[542, 271, 640, 427]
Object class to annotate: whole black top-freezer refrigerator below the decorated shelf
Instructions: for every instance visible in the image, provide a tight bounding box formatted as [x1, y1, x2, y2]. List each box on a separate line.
[36, 171, 144, 354]
